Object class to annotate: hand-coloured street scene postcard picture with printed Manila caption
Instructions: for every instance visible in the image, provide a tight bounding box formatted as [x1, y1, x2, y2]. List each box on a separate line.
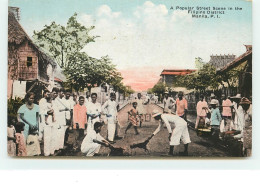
[7, 0, 253, 159]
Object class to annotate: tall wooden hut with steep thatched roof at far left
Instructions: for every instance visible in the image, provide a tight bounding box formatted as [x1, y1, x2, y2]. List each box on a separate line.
[8, 11, 56, 82]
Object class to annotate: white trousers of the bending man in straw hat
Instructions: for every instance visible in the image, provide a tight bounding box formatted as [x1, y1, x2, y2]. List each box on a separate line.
[170, 123, 191, 145]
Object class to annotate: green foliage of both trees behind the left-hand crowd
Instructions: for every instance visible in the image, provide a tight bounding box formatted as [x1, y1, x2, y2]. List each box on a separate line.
[33, 13, 132, 93]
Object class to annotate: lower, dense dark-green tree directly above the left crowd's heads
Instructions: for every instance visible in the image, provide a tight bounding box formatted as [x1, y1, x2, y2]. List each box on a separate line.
[64, 52, 122, 91]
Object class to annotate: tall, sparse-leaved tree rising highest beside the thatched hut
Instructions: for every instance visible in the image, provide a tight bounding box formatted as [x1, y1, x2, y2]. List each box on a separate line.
[33, 13, 97, 69]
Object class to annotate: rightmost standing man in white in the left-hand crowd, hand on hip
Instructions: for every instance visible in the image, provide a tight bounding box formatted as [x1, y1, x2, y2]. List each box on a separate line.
[102, 93, 118, 143]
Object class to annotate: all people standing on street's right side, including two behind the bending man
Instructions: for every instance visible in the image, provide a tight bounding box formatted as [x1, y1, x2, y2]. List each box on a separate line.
[160, 92, 252, 156]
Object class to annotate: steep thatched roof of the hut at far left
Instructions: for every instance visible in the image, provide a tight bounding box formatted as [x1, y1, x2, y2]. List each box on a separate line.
[8, 11, 57, 66]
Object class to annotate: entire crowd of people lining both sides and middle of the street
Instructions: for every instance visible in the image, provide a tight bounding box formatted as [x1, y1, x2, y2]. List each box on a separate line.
[7, 88, 252, 156]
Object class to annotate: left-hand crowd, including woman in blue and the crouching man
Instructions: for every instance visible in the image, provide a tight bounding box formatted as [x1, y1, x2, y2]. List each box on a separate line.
[7, 88, 121, 156]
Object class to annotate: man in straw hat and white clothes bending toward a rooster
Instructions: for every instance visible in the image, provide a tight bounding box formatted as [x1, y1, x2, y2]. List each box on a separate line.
[149, 110, 191, 156]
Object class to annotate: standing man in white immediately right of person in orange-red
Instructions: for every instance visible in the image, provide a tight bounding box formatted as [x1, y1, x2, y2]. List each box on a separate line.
[87, 93, 101, 133]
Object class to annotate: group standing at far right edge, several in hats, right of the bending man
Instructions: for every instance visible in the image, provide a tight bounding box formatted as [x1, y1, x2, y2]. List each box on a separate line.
[195, 93, 252, 156]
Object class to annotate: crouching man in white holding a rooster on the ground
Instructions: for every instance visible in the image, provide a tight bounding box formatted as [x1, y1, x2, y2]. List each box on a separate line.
[81, 122, 111, 157]
